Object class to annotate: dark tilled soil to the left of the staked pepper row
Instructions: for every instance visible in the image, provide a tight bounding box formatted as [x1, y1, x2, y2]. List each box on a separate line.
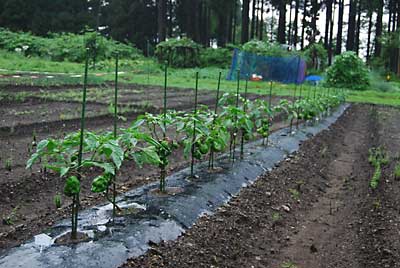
[0, 82, 287, 250]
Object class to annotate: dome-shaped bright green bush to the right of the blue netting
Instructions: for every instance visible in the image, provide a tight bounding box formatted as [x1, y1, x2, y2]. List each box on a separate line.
[326, 51, 370, 90]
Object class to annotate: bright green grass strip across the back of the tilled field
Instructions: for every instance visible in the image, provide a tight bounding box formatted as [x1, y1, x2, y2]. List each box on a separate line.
[0, 50, 400, 107]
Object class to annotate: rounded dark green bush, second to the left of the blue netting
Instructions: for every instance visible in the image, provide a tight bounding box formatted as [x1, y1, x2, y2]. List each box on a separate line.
[156, 37, 201, 68]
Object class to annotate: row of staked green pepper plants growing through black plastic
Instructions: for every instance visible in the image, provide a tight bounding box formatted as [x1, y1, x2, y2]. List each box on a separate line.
[27, 65, 344, 239]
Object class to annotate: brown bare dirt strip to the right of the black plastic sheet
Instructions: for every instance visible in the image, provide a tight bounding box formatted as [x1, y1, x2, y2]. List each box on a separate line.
[125, 105, 400, 268]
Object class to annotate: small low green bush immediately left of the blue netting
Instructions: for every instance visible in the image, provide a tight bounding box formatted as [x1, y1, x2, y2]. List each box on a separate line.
[200, 48, 233, 68]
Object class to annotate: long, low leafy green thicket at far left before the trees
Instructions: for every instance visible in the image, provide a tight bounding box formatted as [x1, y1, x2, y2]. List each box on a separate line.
[0, 28, 141, 62]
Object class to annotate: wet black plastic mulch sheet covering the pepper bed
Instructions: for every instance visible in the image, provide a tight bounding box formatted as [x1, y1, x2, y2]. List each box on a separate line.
[0, 103, 343, 267]
